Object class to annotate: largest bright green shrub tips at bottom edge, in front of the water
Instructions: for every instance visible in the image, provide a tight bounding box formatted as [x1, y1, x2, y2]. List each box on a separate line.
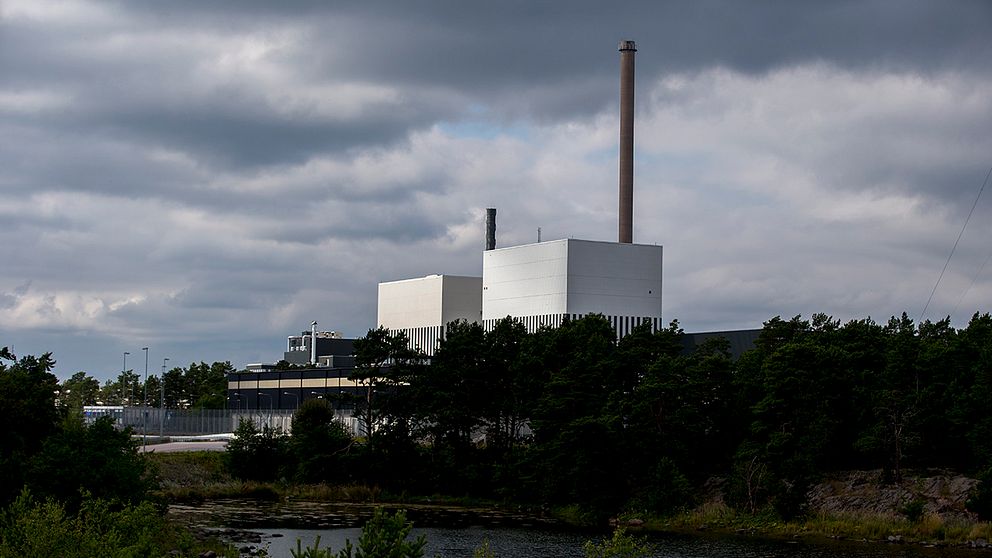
[290, 508, 427, 558]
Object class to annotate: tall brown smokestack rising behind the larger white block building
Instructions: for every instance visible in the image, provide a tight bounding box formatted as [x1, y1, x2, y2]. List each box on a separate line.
[619, 41, 637, 244]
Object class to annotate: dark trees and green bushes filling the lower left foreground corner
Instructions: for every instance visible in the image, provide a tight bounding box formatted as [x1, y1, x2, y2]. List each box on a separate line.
[0, 347, 237, 558]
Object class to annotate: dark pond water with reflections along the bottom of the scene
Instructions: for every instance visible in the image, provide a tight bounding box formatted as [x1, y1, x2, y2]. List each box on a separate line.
[169, 500, 975, 558]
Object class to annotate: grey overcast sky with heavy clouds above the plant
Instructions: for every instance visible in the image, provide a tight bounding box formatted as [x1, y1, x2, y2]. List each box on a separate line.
[0, 0, 992, 380]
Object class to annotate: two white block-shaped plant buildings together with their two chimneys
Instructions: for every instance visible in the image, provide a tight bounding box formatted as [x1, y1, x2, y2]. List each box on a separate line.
[377, 41, 662, 354]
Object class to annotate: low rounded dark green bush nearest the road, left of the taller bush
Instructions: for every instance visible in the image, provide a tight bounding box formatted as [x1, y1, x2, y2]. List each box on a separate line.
[225, 419, 288, 481]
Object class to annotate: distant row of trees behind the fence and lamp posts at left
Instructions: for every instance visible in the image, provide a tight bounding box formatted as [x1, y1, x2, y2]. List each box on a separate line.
[57, 362, 235, 409]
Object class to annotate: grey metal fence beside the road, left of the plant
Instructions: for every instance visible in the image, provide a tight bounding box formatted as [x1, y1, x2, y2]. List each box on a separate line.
[106, 407, 359, 436]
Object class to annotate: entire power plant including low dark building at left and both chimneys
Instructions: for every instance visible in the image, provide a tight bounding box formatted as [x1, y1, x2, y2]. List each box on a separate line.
[228, 41, 760, 409]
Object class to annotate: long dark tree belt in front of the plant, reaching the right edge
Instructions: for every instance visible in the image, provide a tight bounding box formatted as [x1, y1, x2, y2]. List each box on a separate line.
[236, 314, 992, 517]
